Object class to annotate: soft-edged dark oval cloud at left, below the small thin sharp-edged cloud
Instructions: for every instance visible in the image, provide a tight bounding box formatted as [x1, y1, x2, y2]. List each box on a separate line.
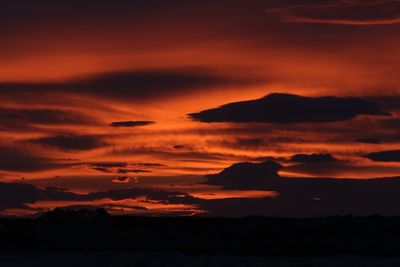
[28, 135, 107, 151]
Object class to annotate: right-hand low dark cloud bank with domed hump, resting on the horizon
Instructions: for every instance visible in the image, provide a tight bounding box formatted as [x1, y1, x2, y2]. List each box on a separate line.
[201, 159, 400, 217]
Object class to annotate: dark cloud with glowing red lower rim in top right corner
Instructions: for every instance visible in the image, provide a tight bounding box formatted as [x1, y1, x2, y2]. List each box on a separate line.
[266, 0, 400, 26]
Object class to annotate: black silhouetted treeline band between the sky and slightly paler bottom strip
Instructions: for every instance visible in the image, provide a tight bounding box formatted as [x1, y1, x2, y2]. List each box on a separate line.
[0, 209, 400, 256]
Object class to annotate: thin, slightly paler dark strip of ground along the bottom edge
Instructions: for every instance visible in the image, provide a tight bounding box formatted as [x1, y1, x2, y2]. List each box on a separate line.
[0, 251, 400, 267]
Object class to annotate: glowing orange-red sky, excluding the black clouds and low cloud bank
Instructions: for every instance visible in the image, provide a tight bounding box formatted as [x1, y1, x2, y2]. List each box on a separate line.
[0, 0, 400, 218]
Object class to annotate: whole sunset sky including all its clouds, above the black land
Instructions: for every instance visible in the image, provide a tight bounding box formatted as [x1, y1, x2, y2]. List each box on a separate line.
[0, 0, 400, 217]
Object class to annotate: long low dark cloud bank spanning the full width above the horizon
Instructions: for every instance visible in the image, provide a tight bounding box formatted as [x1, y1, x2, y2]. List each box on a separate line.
[5, 162, 400, 217]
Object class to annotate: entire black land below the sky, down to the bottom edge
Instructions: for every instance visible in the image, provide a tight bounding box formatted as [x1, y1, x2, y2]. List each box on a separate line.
[0, 211, 400, 267]
